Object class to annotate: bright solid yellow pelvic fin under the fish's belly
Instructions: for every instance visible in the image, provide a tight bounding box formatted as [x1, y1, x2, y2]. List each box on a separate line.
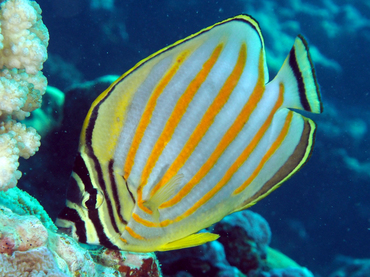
[158, 233, 220, 251]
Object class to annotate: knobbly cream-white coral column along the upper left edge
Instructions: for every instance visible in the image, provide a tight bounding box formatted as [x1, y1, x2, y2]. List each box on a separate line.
[0, 0, 49, 190]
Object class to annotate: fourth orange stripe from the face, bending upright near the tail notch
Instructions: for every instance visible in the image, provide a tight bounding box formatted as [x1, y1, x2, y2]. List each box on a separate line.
[160, 47, 265, 209]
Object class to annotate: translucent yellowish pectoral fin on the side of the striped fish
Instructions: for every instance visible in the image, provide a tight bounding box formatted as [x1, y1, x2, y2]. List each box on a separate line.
[143, 173, 184, 221]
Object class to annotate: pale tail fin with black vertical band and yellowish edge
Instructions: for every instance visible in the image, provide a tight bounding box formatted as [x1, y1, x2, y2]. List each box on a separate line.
[271, 35, 323, 113]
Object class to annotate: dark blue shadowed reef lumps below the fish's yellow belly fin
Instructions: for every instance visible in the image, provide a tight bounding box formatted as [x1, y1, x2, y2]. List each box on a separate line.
[157, 210, 313, 277]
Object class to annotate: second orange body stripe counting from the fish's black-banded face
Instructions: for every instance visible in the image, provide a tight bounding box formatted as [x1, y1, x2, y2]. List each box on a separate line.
[141, 44, 223, 196]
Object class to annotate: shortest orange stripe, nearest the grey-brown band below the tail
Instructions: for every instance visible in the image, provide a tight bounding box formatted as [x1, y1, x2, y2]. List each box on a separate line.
[233, 104, 293, 195]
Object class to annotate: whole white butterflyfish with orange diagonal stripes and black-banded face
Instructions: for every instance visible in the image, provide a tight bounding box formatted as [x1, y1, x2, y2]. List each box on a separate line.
[56, 15, 323, 252]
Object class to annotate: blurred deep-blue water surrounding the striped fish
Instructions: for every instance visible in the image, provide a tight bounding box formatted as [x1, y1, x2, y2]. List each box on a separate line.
[18, 0, 370, 276]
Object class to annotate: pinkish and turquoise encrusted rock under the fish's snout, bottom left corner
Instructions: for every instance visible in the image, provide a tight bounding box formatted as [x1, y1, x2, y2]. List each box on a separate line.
[0, 187, 161, 277]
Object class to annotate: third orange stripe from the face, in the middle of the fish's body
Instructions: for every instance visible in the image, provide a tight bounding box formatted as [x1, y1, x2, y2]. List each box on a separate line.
[146, 43, 247, 205]
